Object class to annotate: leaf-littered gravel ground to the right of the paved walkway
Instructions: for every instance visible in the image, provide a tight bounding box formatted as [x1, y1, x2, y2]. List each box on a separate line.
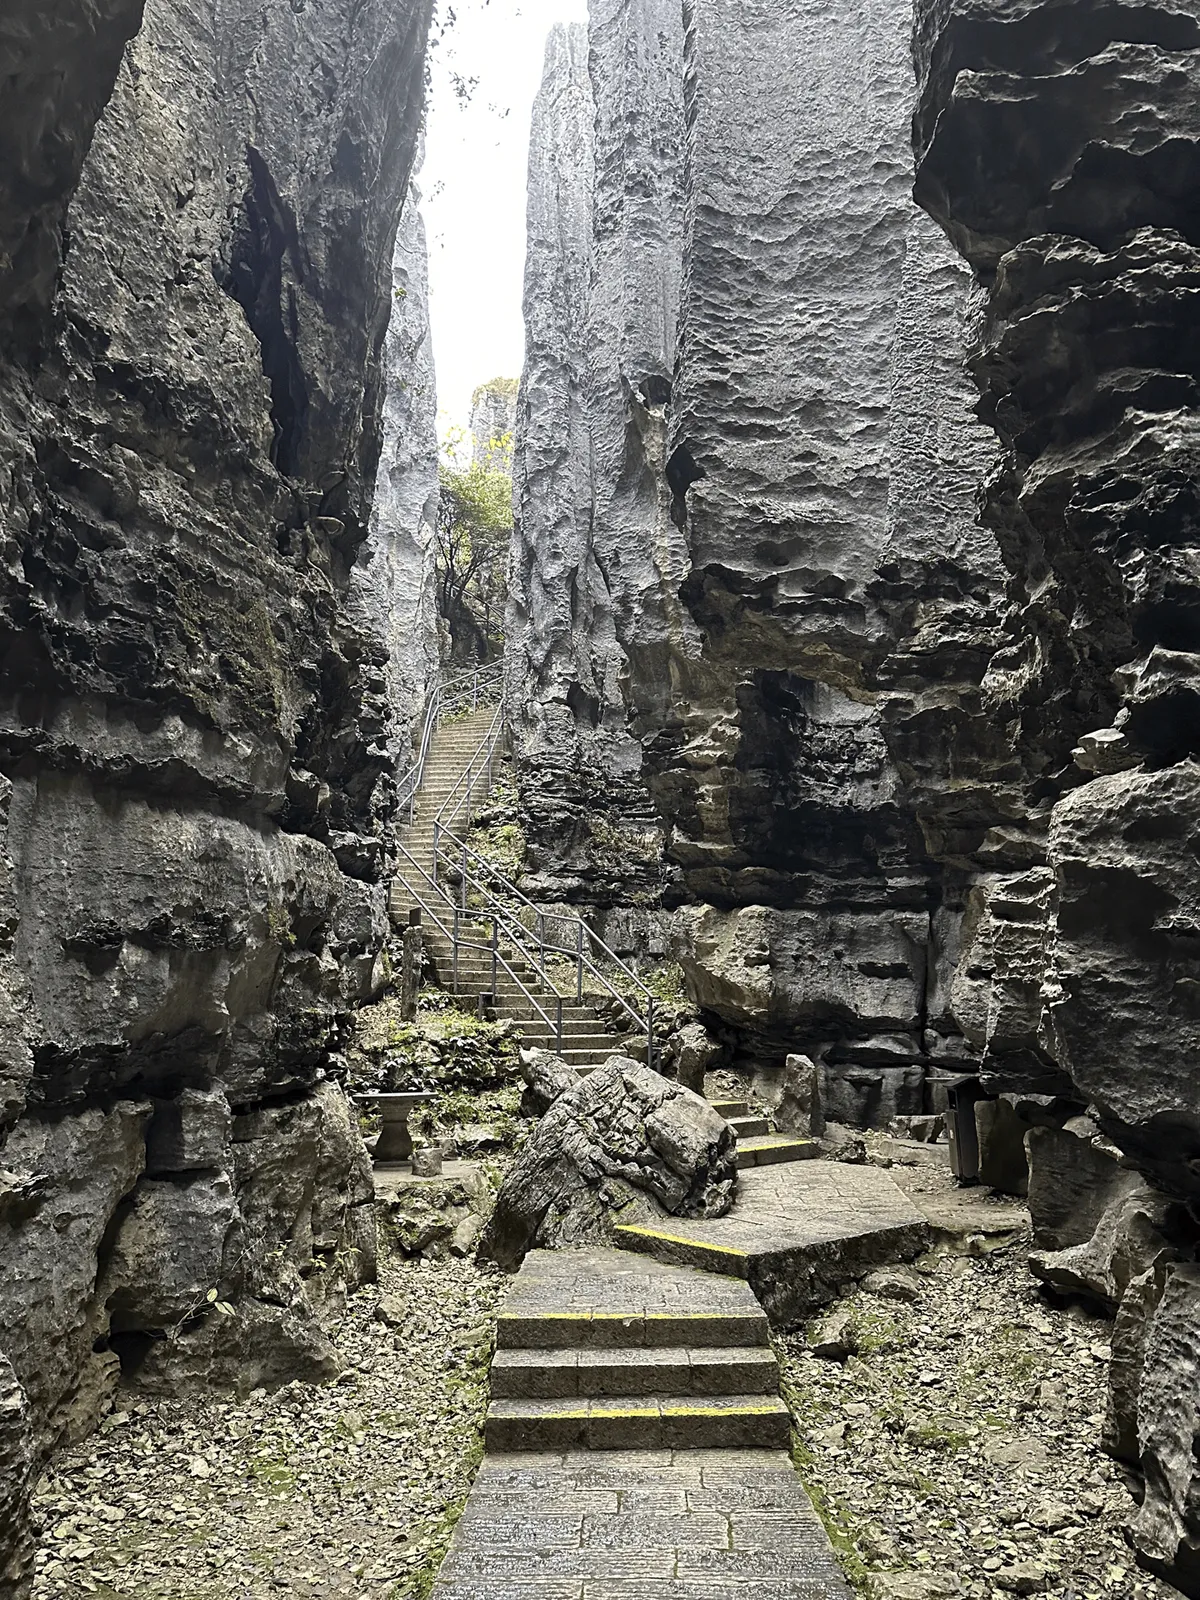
[781, 1246, 1178, 1600]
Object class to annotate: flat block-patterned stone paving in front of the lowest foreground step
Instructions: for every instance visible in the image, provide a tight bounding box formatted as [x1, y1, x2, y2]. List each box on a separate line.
[432, 1450, 851, 1600]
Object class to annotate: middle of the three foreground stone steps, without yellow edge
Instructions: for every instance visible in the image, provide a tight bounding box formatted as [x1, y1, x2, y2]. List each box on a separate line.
[491, 1346, 779, 1400]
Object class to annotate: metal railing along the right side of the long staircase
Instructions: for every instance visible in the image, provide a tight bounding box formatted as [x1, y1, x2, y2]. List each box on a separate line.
[410, 707, 654, 1066]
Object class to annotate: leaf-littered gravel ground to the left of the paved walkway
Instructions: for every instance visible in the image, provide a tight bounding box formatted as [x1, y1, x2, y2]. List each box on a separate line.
[34, 1256, 504, 1600]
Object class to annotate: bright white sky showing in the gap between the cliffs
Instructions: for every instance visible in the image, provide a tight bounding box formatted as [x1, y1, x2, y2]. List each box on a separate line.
[418, 0, 587, 437]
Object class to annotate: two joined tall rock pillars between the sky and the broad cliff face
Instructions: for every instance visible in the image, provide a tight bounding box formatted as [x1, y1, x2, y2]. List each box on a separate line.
[509, 0, 686, 941]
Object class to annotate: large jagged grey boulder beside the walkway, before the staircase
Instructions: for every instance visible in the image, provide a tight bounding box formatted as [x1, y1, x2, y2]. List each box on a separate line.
[480, 1056, 738, 1270]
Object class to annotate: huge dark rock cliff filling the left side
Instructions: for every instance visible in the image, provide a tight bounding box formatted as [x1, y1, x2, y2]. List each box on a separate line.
[0, 0, 429, 1594]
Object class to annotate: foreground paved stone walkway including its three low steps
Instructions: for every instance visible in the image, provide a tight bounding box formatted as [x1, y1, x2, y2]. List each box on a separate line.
[434, 1248, 850, 1600]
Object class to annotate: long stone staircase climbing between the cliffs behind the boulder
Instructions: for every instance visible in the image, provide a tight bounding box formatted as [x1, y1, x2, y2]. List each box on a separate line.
[390, 706, 818, 1168]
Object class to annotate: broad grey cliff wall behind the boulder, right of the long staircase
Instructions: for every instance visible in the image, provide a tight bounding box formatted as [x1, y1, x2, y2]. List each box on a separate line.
[510, 0, 1002, 1100]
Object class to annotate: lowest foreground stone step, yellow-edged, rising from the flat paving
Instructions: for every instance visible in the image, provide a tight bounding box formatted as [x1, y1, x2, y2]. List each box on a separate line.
[483, 1395, 792, 1451]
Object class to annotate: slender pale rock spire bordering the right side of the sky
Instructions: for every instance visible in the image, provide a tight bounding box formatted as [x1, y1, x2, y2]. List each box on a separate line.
[506, 26, 611, 902]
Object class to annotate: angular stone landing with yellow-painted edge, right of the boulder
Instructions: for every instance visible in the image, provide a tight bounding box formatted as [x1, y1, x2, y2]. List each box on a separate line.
[614, 1162, 931, 1328]
